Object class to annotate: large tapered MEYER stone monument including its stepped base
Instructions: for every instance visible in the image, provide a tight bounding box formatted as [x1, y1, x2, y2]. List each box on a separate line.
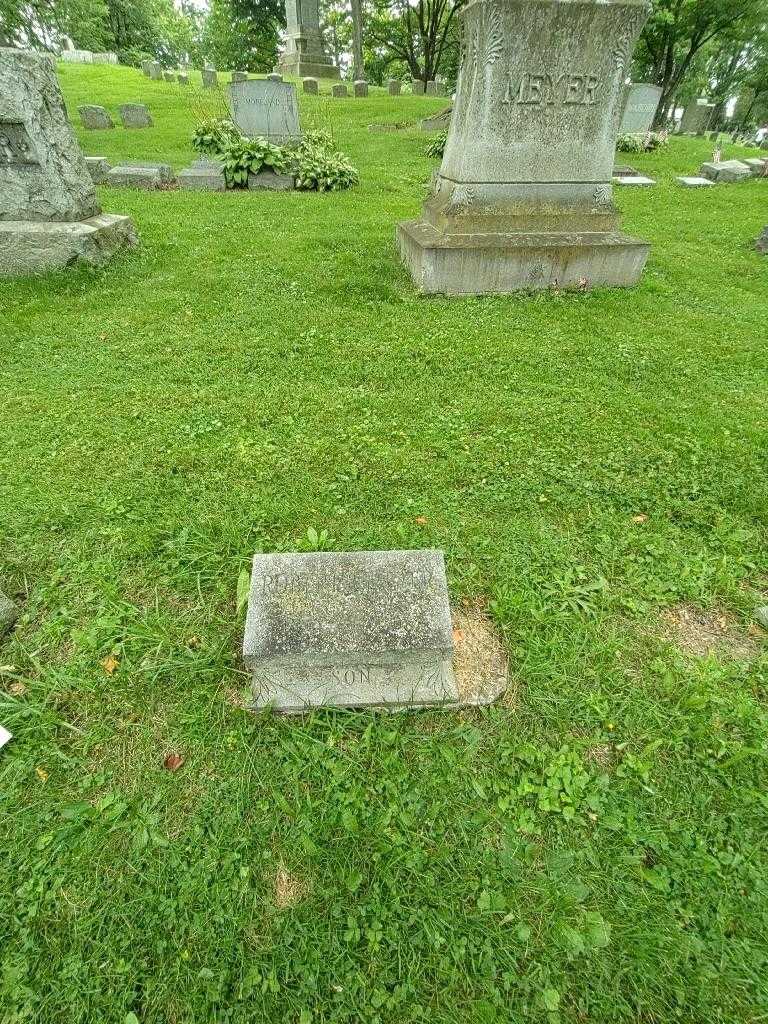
[397, 0, 649, 295]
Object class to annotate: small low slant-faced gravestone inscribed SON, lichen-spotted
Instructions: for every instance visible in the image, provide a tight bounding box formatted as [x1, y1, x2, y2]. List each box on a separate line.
[243, 551, 459, 713]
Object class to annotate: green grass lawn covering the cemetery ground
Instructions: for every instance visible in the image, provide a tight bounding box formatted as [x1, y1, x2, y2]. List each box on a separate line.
[0, 66, 768, 1024]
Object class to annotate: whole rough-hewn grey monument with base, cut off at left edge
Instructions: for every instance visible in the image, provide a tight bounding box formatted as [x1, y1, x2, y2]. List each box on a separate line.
[0, 49, 137, 276]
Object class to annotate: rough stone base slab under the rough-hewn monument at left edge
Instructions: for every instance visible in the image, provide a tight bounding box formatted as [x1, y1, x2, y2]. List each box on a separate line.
[0, 213, 138, 278]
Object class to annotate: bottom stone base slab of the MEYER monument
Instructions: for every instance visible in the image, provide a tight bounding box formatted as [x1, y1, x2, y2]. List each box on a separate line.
[397, 220, 650, 295]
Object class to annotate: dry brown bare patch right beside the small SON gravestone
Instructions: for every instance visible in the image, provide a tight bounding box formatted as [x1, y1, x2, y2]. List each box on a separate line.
[452, 599, 516, 707]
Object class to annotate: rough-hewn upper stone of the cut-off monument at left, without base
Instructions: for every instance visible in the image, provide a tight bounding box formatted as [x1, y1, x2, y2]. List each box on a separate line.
[0, 48, 99, 221]
